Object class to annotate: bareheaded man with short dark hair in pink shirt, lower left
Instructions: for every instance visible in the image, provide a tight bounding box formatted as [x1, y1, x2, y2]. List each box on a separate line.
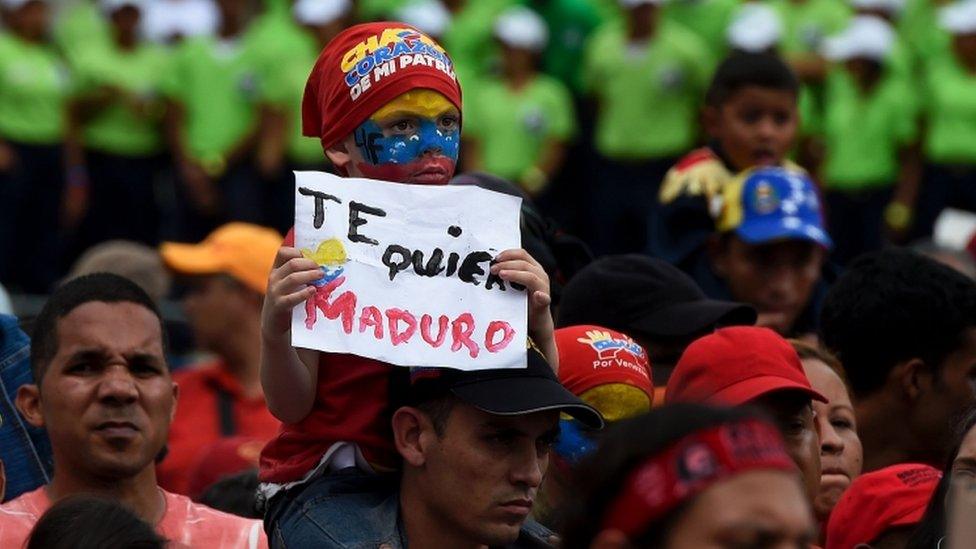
[0, 274, 267, 548]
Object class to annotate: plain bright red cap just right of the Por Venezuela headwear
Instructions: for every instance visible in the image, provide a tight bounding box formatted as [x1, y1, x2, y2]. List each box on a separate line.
[664, 326, 827, 406]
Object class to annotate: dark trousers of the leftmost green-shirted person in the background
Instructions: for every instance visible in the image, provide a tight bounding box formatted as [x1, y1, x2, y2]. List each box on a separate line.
[0, 141, 65, 293]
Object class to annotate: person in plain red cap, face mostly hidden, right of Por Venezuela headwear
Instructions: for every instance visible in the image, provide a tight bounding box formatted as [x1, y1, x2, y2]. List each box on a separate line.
[665, 326, 827, 503]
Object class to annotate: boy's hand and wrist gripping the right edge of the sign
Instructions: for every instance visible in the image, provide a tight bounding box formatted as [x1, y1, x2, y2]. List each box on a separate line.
[491, 249, 554, 344]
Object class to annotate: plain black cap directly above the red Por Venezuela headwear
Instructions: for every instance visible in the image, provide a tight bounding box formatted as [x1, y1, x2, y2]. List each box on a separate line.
[557, 254, 756, 337]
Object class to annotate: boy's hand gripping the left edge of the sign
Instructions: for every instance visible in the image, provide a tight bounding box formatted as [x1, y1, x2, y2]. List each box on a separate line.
[261, 246, 324, 337]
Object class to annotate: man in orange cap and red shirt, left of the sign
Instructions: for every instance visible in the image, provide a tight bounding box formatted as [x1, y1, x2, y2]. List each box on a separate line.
[157, 223, 281, 495]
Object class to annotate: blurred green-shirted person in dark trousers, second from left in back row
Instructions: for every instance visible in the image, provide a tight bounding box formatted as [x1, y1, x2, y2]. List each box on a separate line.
[68, 0, 167, 254]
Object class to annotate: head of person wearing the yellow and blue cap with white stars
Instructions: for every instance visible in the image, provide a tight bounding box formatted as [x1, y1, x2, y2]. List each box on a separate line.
[690, 168, 833, 337]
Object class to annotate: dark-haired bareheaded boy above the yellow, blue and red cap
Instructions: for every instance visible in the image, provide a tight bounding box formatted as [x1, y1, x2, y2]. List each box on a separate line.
[648, 53, 800, 270]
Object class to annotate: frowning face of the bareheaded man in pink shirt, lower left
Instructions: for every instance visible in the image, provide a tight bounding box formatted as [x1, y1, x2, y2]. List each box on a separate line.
[18, 301, 177, 480]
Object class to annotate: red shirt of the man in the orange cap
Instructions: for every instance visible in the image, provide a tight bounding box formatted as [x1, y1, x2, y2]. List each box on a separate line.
[156, 361, 281, 494]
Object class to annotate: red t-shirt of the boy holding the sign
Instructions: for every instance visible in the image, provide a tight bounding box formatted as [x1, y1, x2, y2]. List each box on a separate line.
[259, 229, 400, 484]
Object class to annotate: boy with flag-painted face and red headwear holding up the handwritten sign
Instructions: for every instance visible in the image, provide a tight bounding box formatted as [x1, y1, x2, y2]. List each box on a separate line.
[255, 23, 556, 545]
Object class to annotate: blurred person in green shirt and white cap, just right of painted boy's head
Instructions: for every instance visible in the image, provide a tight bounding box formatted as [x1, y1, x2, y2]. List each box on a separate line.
[464, 6, 575, 196]
